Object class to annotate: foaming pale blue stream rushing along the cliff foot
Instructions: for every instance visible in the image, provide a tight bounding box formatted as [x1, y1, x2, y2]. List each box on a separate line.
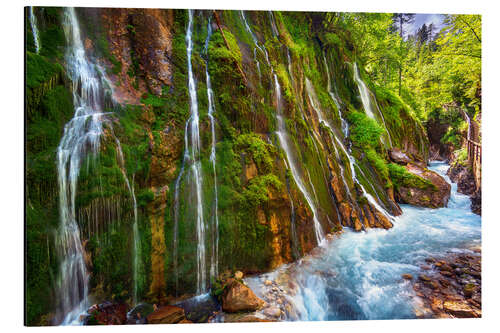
[246, 162, 481, 320]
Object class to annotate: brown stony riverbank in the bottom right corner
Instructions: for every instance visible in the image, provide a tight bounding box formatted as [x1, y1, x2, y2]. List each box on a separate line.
[408, 247, 481, 318]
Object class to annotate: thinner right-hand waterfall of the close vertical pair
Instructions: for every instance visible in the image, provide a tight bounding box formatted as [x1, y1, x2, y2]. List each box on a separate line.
[205, 19, 219, 279]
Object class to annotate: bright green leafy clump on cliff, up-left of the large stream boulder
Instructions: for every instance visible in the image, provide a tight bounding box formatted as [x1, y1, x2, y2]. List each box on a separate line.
[347, 111, 384, 148]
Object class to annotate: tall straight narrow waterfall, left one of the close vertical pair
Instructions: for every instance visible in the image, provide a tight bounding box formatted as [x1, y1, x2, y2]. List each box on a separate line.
[186, 9, 207, 294]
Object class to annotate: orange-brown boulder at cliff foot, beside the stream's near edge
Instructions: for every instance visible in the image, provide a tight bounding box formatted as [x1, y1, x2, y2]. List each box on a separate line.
[222, 279, 265, 312]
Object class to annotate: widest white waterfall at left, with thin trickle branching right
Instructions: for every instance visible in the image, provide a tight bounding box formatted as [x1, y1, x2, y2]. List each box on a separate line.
[56, 8, 138, 324]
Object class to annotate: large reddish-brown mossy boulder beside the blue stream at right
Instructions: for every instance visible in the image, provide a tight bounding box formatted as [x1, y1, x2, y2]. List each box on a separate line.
[396, 164, 451, 208]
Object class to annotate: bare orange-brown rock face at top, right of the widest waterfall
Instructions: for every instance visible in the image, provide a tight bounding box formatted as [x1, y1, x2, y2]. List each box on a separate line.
[100, 8, 173, 104]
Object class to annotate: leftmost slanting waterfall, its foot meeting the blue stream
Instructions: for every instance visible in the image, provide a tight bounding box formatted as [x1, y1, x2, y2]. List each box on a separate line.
[273, 73, 324, 245]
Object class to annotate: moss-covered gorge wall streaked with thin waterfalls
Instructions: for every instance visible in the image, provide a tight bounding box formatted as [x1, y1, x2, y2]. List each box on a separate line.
[26, 8, 437, 324]
